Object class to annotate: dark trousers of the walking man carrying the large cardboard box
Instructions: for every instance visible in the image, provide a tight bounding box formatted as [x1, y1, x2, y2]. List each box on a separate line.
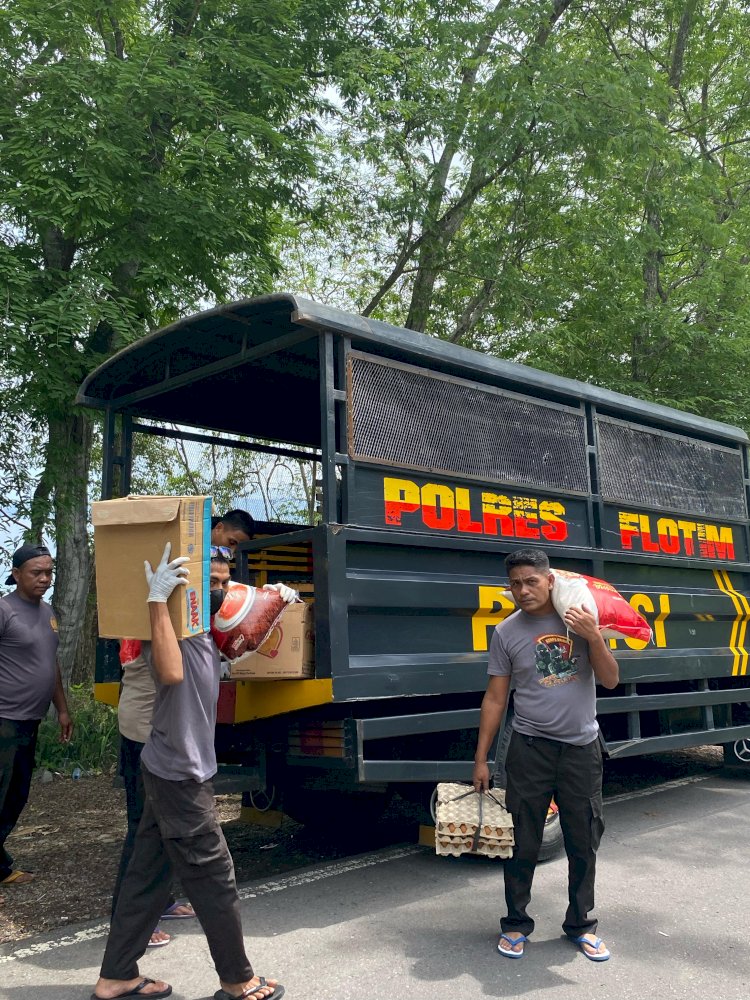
[101, 764, 253, 983]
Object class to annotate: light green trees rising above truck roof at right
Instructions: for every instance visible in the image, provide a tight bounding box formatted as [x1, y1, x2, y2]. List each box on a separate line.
[280, 0, 750, 427]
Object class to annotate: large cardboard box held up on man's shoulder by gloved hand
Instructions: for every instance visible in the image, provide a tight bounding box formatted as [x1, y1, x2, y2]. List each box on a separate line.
[91, 496, 211, 639]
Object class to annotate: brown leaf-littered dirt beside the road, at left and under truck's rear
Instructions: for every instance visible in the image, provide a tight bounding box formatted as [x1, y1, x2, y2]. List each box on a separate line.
[0, 776, 346, 943]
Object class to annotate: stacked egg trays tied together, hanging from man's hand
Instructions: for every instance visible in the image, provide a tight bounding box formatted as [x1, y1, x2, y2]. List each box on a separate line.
[435, 782, 514, 858]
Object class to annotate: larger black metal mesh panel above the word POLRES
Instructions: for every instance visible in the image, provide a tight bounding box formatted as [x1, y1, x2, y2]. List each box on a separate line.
[349, 353, 589, 493]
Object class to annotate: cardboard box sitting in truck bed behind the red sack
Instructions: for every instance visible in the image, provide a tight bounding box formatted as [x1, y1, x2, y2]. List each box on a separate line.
[229, 604, 315, 681]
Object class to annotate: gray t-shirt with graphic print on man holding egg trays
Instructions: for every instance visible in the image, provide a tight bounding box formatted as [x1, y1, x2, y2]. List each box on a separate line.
[487, 611, 599, 746]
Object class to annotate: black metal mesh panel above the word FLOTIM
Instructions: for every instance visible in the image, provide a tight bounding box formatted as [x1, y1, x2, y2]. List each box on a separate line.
[597, 416, 746, 518]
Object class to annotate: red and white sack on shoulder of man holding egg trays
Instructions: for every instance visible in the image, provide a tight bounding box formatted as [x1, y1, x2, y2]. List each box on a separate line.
[550, 569, 651, 642]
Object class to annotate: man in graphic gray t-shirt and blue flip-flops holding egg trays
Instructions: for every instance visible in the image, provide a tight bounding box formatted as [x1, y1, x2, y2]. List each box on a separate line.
[473, 549, 619, 962]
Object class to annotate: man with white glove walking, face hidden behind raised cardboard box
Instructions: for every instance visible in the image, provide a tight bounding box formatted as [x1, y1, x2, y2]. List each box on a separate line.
[93, 544, 284, 1000]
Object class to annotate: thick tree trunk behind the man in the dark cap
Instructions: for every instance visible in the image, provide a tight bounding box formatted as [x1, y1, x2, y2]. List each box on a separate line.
[44, 411, 92, 687]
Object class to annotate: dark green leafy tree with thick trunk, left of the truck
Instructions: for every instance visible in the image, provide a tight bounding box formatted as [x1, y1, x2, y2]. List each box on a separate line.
[0, 0, 340, 677]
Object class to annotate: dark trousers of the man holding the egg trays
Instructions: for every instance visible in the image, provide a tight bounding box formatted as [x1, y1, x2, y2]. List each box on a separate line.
[501, 732, 604, 937]
